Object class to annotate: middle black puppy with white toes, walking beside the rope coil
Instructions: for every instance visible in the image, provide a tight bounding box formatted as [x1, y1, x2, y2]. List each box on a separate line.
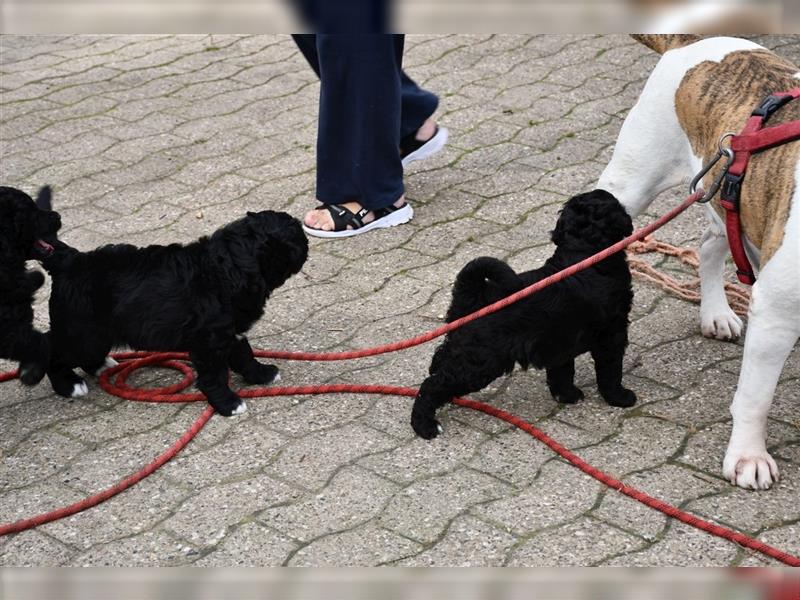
[36, 193, 308, 416]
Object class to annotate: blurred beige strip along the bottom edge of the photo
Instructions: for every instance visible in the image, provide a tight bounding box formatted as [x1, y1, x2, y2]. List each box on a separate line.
[0, 568, 800, 600]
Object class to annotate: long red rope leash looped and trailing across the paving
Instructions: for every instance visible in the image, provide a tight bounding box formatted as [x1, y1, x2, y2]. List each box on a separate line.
[0, 190, 800, 567]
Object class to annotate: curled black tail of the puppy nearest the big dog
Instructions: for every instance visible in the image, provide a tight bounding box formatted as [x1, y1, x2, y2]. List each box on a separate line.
[447, 256, 523, 323]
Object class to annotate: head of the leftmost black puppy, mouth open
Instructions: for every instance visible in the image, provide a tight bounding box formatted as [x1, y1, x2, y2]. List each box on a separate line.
[0, 187, 61, 260]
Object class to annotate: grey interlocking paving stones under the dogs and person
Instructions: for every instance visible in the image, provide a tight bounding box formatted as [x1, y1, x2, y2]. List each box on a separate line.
[0, 35, 800, 566]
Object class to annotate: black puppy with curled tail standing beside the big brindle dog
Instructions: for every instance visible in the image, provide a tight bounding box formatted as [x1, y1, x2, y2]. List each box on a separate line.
[411, 190, 636, 439]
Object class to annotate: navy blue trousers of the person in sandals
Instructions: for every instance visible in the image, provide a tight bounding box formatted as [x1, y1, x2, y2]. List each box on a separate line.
[292, 34, 439, 210]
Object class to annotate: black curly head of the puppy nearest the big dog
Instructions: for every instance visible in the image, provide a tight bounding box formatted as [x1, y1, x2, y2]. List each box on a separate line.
[551, 190, 633, 252]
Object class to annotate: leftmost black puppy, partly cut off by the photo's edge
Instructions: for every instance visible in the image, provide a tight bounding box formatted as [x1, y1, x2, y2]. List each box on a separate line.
[0, 187, 61, 385]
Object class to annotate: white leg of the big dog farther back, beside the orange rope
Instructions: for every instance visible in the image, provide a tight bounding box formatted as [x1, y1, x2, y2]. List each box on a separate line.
[700, 214, 742, 340]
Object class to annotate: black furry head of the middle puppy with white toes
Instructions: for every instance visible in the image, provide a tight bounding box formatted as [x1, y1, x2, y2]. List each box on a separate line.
[211, 210, 308, 290]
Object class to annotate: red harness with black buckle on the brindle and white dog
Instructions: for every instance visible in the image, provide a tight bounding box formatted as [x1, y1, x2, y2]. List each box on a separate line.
[720, 88, 800, 285]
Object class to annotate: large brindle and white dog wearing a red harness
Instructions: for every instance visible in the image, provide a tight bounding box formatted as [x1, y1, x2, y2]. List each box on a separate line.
[597, 35, 800, 489]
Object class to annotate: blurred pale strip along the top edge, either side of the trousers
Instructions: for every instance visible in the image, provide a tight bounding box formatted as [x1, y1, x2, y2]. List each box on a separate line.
[0, 0, 798, 33]
